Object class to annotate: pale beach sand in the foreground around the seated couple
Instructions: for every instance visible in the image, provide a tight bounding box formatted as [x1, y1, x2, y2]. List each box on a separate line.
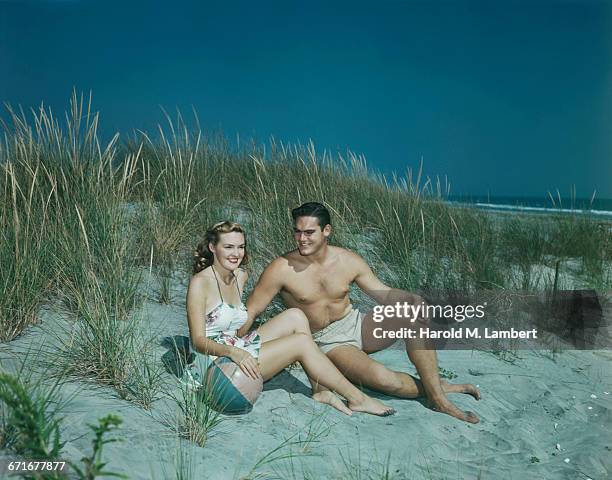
[0, 285, 612, 479]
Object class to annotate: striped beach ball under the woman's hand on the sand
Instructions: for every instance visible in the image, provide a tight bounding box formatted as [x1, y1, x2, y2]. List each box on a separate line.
[204, 357, 263, 414]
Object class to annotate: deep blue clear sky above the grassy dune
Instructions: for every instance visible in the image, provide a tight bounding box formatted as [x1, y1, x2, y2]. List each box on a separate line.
[0, 0, 612, 198]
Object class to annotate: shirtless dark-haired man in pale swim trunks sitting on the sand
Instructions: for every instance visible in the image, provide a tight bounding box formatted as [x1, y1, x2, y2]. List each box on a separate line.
[238, 202, 480, 423]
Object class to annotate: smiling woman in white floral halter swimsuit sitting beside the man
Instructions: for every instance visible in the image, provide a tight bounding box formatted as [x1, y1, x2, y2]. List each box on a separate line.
[186, 221, 395, 416]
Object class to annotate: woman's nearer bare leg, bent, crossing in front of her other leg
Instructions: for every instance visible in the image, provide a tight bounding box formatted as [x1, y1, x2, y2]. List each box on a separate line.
[258, 333, 395, 416]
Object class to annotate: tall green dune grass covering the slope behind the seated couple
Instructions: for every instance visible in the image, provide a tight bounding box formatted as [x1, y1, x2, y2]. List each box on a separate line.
[0, 93, 612, 380]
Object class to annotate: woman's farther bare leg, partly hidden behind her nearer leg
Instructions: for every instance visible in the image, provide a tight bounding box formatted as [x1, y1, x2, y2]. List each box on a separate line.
[257, 308, 351, 415]
